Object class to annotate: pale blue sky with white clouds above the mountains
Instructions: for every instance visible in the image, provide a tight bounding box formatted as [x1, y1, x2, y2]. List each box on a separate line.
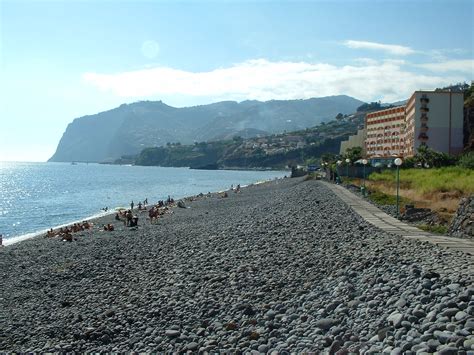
[0, 0, 474, 161]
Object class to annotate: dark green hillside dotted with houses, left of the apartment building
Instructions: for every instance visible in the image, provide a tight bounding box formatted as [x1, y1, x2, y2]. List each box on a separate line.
[135, 115, 363, 169]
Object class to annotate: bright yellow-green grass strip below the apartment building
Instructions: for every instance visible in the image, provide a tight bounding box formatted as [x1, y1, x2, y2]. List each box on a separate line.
[369, 166, 474, 196]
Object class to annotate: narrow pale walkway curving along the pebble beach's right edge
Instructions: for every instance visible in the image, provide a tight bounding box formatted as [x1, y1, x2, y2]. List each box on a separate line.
[321, 181, 474, 256]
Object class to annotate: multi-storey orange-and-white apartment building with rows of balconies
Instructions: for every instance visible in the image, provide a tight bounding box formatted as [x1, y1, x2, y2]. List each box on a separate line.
[365, 91, 464, 159]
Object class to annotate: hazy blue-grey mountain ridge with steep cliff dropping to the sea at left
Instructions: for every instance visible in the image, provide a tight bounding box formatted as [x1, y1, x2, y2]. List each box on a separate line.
[48, 95, 363, 162]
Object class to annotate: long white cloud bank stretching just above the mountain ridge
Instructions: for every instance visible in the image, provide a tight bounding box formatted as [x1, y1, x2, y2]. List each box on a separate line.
[83, 59, 466, 102]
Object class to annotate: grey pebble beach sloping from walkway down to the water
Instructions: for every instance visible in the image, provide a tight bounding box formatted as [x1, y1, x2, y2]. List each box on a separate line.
[0, 178, 474, 354]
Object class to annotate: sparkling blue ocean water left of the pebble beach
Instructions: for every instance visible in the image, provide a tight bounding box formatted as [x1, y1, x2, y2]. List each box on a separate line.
[0, 162, 288, 245]
